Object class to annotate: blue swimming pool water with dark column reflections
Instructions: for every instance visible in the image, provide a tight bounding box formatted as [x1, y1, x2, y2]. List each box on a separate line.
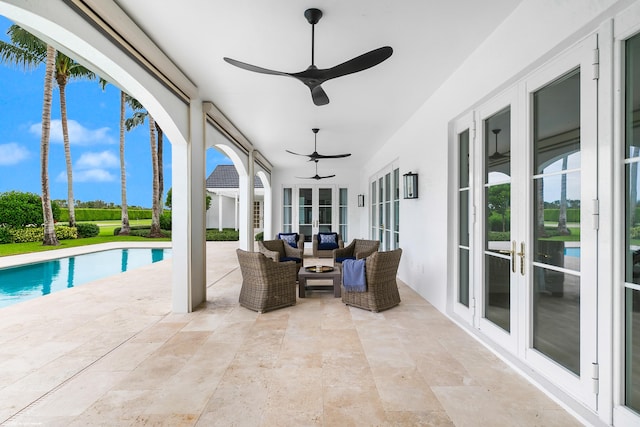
[0, 248, 171, 307]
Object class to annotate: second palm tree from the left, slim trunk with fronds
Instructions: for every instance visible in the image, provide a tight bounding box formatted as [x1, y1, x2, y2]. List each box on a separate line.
[56, 52, 96, 227]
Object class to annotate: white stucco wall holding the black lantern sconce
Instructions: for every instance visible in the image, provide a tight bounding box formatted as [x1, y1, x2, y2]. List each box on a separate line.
[356, 0, 632, 312]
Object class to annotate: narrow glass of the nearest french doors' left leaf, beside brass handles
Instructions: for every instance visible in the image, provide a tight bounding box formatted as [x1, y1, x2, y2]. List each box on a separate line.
[483, 107, 515, 332]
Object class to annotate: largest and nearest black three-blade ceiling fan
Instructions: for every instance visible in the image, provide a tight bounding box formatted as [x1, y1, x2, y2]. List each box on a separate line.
[223, 9, 393, 105]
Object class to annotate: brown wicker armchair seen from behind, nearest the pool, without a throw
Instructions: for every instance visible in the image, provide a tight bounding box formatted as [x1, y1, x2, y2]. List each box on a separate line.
[236, 249, 297, 313]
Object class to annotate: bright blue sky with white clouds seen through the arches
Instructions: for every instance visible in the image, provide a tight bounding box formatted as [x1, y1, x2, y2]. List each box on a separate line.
[0, 16, 231, 207]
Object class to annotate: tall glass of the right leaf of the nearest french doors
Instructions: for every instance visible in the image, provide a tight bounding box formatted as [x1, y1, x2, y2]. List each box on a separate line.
[532, 70, 581, 375]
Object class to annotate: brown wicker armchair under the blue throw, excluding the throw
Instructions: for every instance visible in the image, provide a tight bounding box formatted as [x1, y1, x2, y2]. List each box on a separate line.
[342, 249, 402, 313]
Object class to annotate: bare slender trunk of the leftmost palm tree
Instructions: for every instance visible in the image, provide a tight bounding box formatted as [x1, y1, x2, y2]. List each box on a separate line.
[40, 45, 60, 246]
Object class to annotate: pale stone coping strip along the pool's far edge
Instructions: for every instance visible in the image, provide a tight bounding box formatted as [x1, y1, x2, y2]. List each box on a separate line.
[0, 241, 172, 268]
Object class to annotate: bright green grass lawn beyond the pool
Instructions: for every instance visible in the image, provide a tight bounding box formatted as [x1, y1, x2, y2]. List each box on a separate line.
[0, 219, 171, 256]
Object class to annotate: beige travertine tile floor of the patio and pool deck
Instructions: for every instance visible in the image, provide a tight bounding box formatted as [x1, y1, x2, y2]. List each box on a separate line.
[0, 242, 581, 426]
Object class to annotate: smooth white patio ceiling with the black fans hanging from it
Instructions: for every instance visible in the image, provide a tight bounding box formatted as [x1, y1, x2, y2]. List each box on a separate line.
[116, 0, 521, 175]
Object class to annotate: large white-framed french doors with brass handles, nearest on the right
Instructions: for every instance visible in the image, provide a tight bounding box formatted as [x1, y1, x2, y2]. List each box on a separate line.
[453, 36, 598, 408]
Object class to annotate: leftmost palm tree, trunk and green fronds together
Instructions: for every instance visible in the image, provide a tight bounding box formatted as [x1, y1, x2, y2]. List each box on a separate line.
[0, 25, 59, 246]
